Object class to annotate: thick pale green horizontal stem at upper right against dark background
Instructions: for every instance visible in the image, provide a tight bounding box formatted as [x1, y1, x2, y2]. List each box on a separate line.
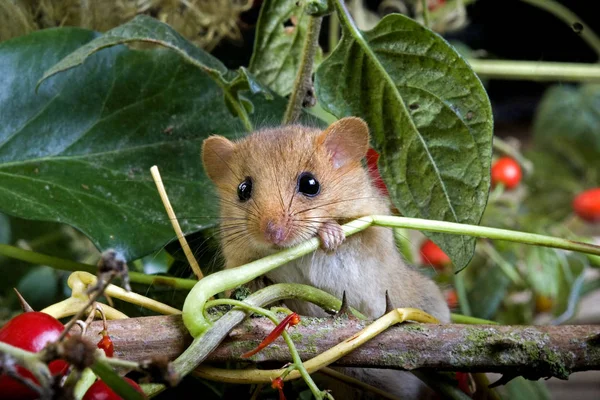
[467, 58, 600, 82]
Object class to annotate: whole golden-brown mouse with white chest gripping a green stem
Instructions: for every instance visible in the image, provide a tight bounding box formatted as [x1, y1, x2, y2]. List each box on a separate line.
[202, 117, 450, 398]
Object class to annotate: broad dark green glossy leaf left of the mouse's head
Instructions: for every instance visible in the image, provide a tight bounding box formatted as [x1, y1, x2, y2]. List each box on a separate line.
[0, 29, 285, 259]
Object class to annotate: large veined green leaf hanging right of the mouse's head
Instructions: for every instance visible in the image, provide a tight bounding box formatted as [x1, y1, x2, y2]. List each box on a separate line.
[315, 8, 492, 268]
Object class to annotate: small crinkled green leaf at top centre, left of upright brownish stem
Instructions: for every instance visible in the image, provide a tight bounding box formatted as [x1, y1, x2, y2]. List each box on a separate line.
[250, 0, 310, 96]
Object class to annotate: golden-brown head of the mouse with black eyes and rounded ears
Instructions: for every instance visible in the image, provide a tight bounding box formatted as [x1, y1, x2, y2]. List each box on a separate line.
[202, 117, 380, 254]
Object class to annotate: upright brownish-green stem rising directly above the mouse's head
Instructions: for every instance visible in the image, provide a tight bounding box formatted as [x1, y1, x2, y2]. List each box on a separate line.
[283, 16, 323, 125]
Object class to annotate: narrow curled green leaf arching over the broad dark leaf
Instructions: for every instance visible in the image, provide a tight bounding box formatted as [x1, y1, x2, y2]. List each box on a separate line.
[38, 15, 272, 125]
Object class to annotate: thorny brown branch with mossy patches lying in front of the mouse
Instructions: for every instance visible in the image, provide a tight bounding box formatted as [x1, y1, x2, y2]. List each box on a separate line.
[87, 316, 600, 379]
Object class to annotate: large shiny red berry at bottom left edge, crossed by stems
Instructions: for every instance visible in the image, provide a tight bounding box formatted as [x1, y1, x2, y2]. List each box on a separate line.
[0, 311, 69, 399]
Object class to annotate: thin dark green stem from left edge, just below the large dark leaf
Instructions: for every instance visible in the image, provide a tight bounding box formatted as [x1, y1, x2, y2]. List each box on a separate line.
[0, 244, 198, 290]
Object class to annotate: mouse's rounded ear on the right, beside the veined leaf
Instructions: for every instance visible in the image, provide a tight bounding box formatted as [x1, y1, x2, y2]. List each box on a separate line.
[317, 117, 369, 168]
